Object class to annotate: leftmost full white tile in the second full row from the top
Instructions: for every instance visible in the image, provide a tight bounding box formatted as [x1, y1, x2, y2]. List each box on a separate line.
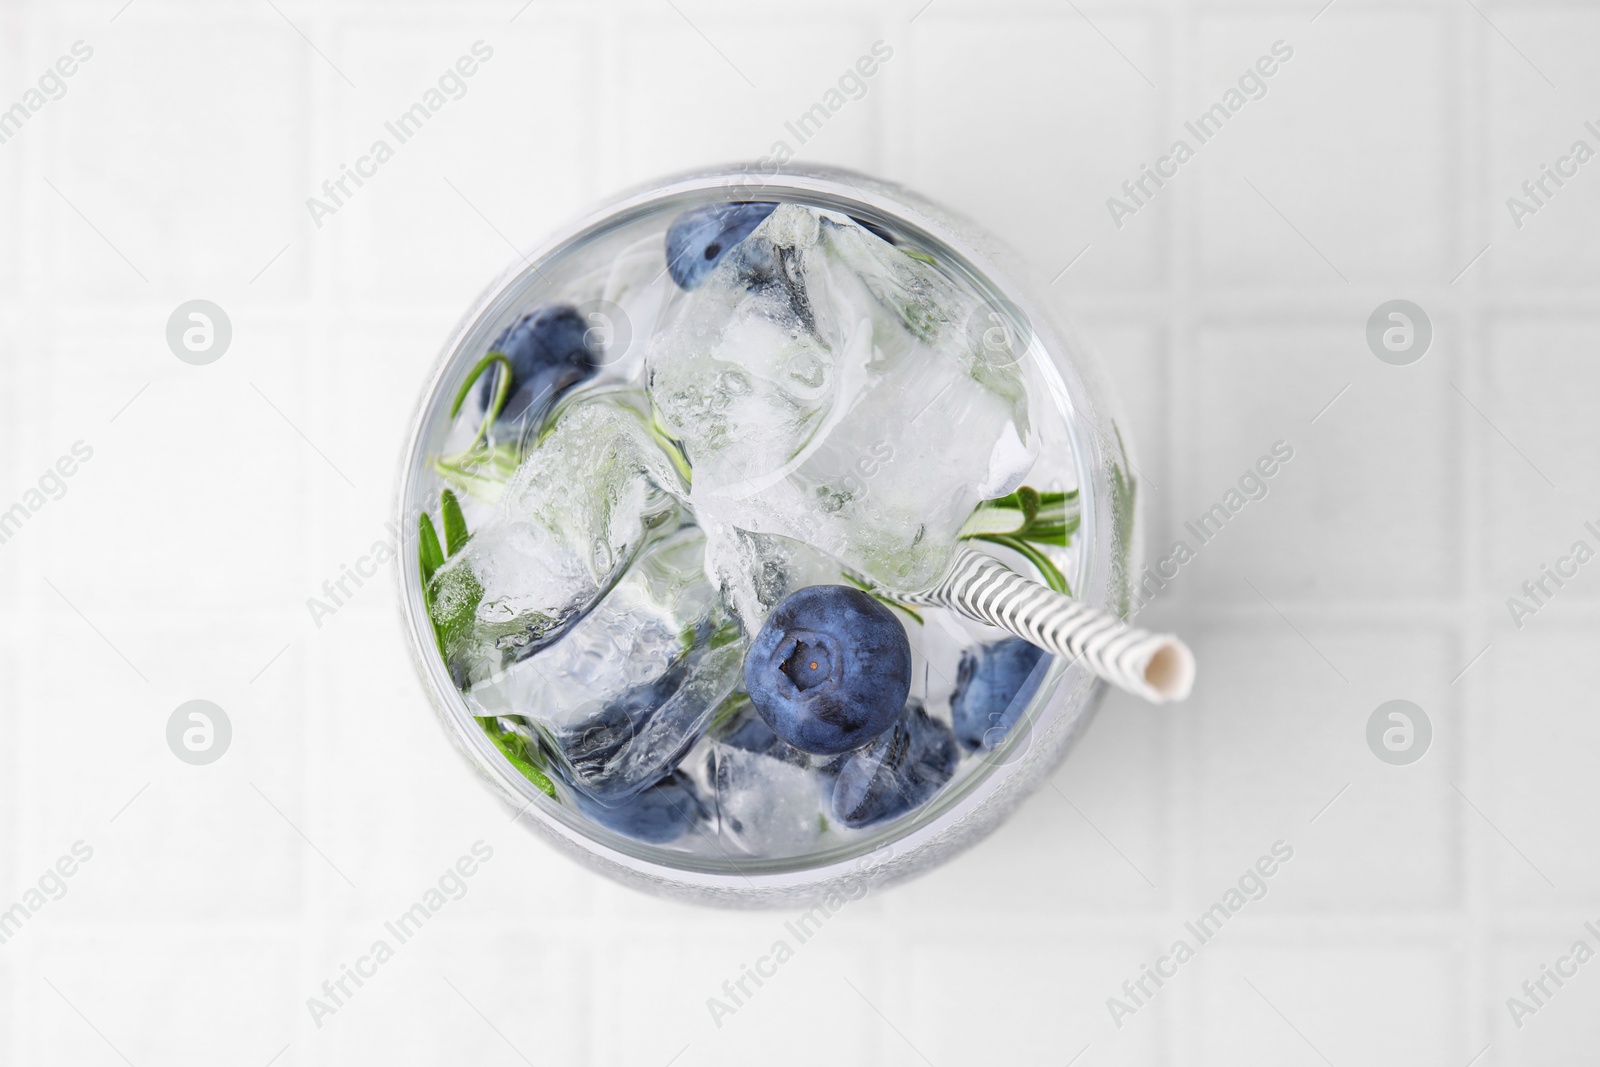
[10, 314, 312, 617]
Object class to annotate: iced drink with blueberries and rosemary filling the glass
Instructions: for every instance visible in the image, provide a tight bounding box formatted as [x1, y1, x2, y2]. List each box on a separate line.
[403, 168, 1133, 888]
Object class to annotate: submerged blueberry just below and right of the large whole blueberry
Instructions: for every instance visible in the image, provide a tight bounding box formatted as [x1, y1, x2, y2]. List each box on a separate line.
[834, 701, 960, 829]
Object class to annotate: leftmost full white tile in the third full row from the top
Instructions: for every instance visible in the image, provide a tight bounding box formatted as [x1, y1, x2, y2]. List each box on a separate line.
[18, 620, 308, 923]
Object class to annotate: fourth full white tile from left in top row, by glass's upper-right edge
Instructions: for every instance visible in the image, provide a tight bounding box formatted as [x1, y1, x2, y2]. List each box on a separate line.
[899, 8, 1173, 291]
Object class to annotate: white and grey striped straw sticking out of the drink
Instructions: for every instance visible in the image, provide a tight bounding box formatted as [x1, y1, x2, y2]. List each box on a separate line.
[893, 545, 1195, 704]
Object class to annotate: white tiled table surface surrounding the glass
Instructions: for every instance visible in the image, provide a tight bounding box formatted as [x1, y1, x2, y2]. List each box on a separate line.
[0, 0, 1600, 1067]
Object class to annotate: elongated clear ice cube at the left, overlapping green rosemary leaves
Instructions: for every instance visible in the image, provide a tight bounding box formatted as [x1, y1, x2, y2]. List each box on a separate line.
[429, 390, 686, 688]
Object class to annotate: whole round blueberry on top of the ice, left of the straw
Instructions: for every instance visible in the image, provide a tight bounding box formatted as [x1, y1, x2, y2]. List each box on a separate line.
[744, 585, 910, 755]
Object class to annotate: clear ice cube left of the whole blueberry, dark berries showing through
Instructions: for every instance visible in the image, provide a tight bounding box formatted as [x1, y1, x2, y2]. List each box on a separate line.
[469, 526, 744, 803]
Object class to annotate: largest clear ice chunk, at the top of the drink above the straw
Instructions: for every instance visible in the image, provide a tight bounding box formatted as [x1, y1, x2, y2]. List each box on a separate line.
[646, 205, 1037, 590]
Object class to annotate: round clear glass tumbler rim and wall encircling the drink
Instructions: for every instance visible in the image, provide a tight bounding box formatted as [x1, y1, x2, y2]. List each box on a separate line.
[397, 166, 1139, 907]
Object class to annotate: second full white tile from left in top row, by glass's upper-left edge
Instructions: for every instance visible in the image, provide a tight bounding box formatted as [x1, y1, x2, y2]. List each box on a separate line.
[321, 13, 595, 308]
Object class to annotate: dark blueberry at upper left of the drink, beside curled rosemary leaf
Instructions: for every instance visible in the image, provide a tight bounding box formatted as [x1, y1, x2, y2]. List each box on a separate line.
[478, 304, 603, 422]
